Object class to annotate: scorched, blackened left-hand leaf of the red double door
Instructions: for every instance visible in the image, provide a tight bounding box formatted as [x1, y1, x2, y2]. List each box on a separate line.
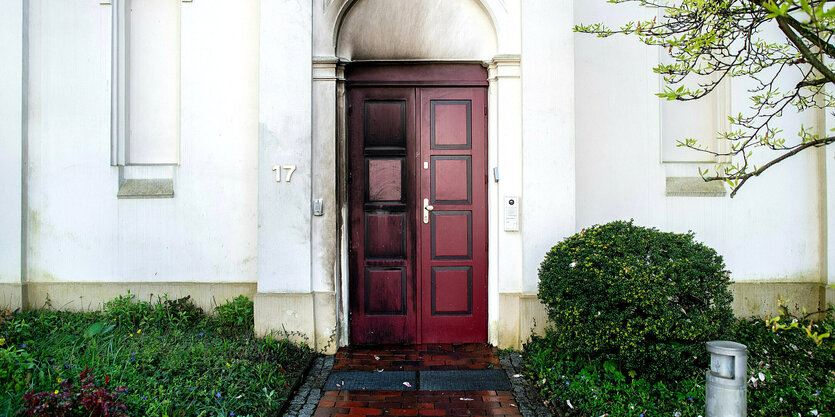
[348, 88, 418, 344]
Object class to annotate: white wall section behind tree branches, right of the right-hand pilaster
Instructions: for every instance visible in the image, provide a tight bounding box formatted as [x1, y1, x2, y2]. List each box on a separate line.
[574, 0, 824, 282]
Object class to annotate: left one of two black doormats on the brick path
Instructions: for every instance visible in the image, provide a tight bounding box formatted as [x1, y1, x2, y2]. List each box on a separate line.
[325, 371, 418, 391]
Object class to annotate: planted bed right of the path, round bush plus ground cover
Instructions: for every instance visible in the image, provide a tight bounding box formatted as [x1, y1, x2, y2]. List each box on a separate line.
[524, 222, 835, 417]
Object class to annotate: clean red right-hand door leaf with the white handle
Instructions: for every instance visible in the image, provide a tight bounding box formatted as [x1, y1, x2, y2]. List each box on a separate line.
[417, 88, 487, 343]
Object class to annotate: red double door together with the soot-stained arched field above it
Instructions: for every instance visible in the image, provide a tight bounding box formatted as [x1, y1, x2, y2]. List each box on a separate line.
[335, 0, 497, 343]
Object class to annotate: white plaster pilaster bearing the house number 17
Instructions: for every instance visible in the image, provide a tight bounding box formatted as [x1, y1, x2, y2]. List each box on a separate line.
[258, 0, 315, 293]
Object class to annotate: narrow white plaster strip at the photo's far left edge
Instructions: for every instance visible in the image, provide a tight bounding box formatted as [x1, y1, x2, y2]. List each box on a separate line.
[0, 0, 23, 286]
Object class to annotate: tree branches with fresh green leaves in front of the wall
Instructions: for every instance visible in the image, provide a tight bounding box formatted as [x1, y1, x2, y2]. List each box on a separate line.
[575, 0, 835, 197]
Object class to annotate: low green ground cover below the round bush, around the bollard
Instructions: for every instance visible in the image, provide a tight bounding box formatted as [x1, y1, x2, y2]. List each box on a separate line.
[523, 312, 835, 417]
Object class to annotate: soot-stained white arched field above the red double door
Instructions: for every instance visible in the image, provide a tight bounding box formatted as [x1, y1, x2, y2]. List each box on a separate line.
[334, 0, 498, 61]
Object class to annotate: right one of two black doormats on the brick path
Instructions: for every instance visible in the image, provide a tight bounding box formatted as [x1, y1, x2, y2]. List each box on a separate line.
[420, 369, 510, 391]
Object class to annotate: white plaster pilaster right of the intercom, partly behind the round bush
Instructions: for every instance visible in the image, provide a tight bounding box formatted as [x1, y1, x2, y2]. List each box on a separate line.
[520, 1, 575, 293]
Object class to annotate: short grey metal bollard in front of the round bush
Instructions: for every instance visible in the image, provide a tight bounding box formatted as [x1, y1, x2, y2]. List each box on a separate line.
[705, 341, 748, 417]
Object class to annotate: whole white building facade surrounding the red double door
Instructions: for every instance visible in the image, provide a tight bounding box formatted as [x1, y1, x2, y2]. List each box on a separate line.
[0, 0, 835, 350]
